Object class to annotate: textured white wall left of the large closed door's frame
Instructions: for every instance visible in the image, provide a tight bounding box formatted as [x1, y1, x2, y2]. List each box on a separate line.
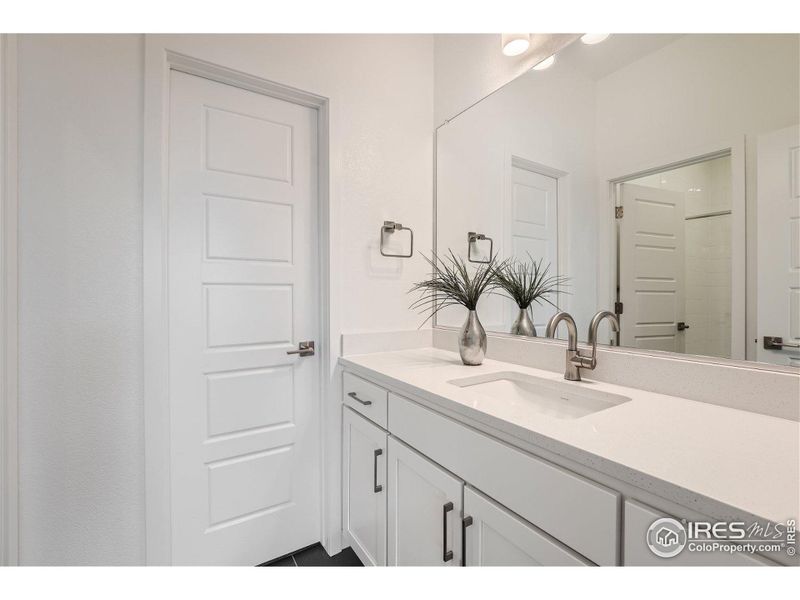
[19, 36, 144, 564]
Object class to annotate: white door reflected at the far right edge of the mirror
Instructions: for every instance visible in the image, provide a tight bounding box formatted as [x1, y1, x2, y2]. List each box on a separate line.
[756, 126, 800, 366]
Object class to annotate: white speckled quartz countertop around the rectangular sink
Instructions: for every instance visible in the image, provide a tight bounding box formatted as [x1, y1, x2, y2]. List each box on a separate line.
[339, 348, 800, 522]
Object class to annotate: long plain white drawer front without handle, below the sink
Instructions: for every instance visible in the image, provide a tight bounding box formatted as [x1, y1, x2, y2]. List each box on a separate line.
[389, 394, 620, 565]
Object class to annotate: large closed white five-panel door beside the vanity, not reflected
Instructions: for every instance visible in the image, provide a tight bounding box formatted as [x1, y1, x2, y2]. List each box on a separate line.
[168, 71, 320, 565]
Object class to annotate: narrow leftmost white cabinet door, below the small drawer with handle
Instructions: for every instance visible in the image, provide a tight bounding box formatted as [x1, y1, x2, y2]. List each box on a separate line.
[342, 407, 387, 566]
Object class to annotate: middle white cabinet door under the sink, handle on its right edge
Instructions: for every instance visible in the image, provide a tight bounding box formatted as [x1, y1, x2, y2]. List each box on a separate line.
[388, 436, 464, 567]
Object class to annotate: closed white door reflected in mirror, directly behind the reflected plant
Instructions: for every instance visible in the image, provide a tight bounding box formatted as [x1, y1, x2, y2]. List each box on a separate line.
[504, 164, 558, 335]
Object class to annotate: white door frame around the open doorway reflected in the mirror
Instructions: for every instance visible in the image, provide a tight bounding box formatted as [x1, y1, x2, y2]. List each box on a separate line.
[598, 136, 754, 360]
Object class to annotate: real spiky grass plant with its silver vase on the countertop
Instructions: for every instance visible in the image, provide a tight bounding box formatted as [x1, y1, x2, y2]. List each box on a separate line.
[410, 250, 497, 365]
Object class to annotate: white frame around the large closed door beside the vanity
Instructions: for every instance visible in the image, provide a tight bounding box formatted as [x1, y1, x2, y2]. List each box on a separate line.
[142, 44, 332, 565]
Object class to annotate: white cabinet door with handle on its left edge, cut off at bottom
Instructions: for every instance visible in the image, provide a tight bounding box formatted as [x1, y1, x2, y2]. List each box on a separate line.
[463, 487, 591, 567]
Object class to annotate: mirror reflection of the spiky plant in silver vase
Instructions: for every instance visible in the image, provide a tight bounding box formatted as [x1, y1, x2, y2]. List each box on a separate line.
[494, 254, 568, 337]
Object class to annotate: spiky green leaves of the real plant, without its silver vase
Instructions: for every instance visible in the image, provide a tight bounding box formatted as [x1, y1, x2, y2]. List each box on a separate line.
[409, 250, 499, 327]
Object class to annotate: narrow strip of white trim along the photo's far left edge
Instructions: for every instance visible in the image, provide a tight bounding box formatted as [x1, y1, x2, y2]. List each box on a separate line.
[0, 34, 19, 566]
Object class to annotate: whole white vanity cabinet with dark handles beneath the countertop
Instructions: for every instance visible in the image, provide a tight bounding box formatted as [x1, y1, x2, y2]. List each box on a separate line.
[342, 366, 770, 566]
